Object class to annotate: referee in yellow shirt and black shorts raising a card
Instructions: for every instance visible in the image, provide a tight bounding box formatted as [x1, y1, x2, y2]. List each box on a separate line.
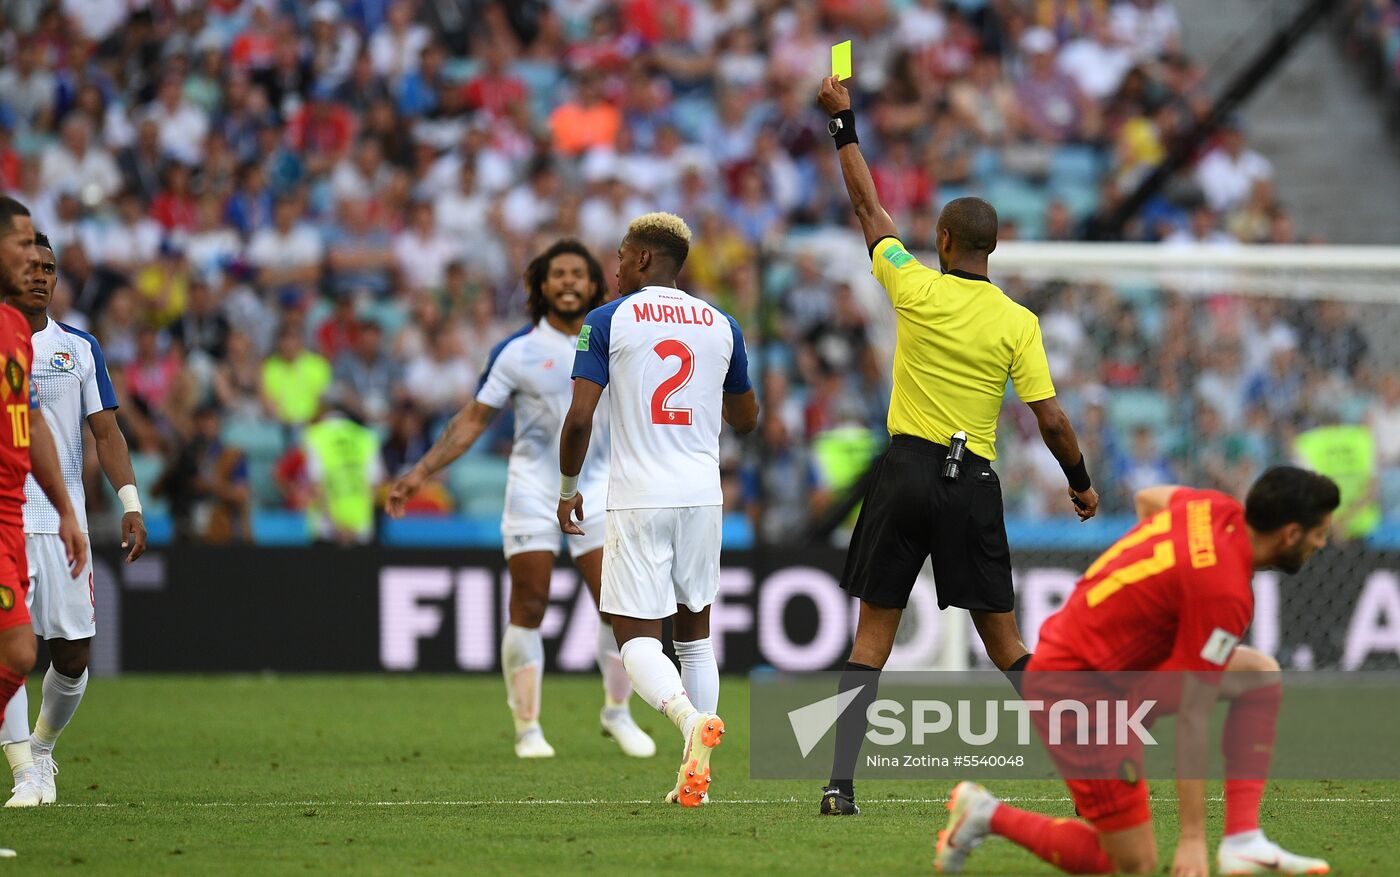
[818, 77, 1099, 815]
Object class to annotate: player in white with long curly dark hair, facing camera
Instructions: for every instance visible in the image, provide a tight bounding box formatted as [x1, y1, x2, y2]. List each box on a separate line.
[386, 240, 657, 758]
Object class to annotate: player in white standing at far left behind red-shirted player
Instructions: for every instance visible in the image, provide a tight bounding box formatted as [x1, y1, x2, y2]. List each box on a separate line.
[0, 234, 146, 807]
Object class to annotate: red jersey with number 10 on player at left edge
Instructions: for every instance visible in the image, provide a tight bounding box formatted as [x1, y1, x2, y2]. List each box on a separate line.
[0, 304, 39, 527]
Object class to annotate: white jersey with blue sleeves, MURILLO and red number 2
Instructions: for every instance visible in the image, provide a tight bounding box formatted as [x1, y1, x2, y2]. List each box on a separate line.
[574, 286, 752, 510]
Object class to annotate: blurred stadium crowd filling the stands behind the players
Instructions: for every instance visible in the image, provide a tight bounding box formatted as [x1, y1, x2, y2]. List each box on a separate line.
[0, 0, 1400, 539]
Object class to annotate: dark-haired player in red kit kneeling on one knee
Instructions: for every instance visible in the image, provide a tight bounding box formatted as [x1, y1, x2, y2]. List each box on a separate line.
[935, 467, 1340, 877]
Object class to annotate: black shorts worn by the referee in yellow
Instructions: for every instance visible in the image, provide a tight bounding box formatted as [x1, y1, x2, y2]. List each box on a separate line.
[841, 436, 1015, 612]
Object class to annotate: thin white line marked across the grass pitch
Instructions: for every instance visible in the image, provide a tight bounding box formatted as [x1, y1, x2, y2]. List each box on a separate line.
[50, 796, 1400, 810]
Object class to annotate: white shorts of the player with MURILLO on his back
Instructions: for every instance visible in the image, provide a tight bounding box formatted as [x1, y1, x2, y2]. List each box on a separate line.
[598, 506, 724, 618]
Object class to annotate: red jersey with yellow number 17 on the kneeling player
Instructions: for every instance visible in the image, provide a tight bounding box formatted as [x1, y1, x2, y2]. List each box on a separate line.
[1030, 488, 1254, 672]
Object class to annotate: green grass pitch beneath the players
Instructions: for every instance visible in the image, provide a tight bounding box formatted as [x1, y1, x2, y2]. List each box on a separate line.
[0, 677, 1400, 877]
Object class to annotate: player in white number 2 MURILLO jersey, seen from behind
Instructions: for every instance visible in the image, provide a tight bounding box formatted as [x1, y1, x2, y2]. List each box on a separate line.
[557, 213, 759, 807]
